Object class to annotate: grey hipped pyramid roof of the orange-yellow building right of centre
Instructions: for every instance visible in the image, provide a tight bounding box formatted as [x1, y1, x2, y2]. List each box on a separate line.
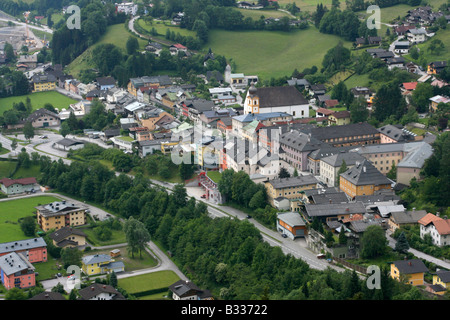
[340, 159, 392, 186]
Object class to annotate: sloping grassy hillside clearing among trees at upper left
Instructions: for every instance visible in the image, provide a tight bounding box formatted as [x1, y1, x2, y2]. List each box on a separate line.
[65, 23, 148, 78]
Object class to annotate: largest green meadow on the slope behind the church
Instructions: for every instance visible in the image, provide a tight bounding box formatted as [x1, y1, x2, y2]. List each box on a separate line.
[204, 26, 352, 80]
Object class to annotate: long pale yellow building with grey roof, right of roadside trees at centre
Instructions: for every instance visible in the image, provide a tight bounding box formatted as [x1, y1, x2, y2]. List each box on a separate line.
[265, 175, 319, 206]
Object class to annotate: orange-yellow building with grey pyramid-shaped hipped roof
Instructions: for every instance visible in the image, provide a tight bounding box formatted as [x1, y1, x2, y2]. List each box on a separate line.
[339, 160, 392, 199]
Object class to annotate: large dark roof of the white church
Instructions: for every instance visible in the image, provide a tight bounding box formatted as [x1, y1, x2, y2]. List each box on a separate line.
[250, 86, 308, 108]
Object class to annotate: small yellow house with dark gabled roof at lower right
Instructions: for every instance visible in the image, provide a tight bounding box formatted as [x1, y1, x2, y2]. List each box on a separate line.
[391, 259, 428, 286]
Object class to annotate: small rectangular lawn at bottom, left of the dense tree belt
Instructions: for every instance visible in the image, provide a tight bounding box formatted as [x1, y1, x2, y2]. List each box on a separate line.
[118, 270, 180, 294]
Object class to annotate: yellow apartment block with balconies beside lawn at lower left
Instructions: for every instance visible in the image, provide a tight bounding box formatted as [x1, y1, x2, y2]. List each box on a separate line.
[35, 200, 87, 231]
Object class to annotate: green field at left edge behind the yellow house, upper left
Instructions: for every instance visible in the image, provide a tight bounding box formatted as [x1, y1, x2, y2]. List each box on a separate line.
[0, 91, 77, 114]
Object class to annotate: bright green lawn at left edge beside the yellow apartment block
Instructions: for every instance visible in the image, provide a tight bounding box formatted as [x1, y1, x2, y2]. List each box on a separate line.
[0, 196, 60, 243]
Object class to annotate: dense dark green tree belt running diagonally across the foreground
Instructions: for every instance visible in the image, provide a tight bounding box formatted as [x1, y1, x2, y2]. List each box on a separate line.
[29, 156, 432, 300]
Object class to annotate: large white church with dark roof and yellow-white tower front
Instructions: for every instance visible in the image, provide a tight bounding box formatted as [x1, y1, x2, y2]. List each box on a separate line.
[244, 83, 309, 118]
